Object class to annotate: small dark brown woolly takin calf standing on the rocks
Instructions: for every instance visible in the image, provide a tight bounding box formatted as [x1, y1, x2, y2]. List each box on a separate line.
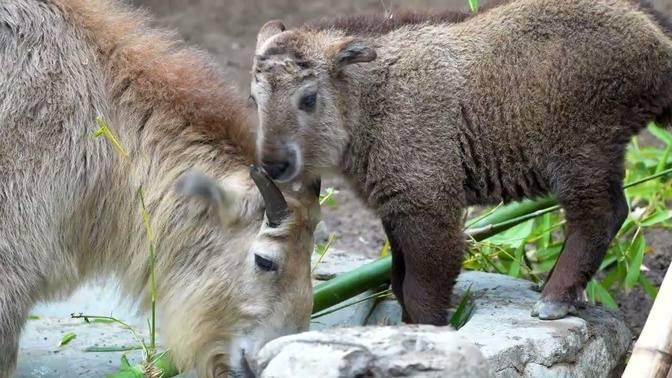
[251, 0, 672, 325]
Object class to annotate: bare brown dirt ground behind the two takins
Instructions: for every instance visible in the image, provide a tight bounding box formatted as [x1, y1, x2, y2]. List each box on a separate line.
[131, 0, 672, 334]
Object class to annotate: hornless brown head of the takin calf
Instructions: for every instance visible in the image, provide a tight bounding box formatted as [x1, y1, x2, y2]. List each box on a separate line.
[250, 21, 376, 182]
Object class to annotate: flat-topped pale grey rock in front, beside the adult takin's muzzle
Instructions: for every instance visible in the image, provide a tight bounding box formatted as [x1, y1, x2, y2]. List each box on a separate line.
[257, 326, 490, 378]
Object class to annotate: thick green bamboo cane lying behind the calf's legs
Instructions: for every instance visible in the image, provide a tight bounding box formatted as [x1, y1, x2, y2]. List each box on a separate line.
[313, 168, 672, 313]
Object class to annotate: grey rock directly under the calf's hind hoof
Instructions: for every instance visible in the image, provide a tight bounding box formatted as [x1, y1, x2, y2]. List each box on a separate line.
[456, 272, 632, 378]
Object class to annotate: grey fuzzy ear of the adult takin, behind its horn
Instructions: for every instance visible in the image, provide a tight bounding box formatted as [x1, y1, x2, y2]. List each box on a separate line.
[176, 171, 237, 224]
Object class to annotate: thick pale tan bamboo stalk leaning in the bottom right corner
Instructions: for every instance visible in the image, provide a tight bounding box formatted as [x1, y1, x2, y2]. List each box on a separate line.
[623, 267, 672, 378]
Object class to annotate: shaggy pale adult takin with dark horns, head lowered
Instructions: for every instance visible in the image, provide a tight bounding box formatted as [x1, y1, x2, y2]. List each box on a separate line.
[0, 0, 319, 378]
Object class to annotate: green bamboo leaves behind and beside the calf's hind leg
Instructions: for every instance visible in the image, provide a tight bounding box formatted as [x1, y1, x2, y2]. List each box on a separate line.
[464, 124, 672, 308]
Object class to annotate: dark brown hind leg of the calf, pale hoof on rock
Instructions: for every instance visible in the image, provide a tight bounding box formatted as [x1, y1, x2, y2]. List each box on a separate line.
[532, 159, 628, 320]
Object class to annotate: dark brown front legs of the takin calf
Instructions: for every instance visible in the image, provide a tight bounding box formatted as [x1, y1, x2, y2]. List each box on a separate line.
[384, 209, 464, 325]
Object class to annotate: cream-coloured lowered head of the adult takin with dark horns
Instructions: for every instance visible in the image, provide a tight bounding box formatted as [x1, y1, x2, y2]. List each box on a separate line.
[163, 166, 320, 377]
